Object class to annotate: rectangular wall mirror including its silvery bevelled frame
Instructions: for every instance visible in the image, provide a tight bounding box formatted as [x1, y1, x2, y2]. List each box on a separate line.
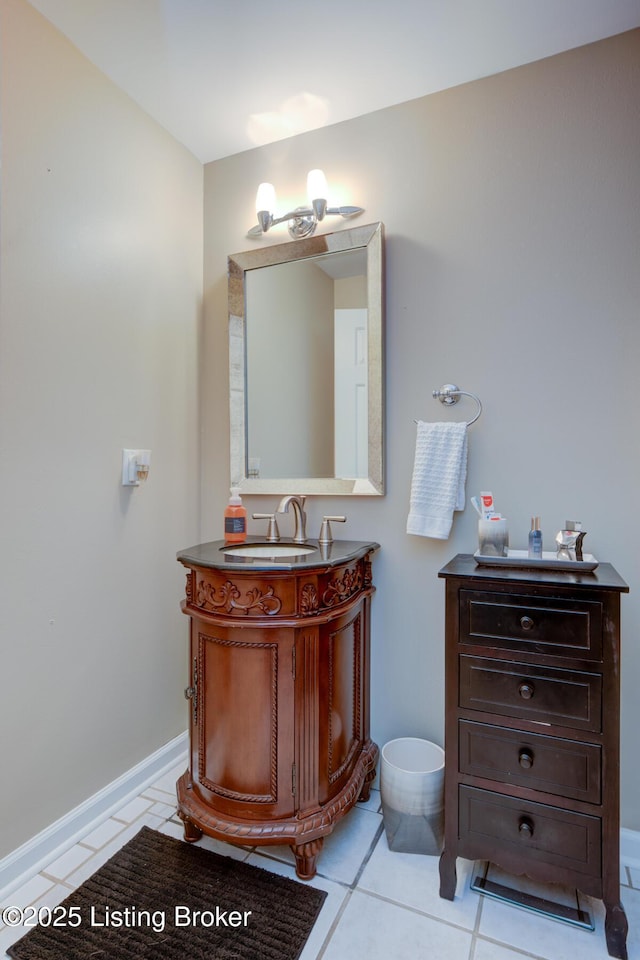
[228, 223, 384, 496]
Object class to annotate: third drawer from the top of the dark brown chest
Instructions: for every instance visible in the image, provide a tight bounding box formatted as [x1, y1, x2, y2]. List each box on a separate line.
[458, 720, 602, 803]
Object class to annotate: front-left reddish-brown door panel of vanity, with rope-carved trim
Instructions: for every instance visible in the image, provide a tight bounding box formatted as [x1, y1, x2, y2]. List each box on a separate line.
[191, 620, 294, 820]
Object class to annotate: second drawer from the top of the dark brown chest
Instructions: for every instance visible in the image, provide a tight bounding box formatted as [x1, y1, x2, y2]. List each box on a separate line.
[459, 655, 602, 732]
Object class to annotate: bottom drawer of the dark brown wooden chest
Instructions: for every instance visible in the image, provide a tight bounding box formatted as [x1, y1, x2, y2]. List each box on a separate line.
[458, 785, 602, 877]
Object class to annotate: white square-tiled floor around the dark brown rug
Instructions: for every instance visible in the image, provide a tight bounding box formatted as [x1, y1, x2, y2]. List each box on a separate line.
[0, 765, 640, 960]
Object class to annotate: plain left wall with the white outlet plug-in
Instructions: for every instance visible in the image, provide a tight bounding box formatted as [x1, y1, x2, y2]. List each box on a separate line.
[0, 0, 202, 858]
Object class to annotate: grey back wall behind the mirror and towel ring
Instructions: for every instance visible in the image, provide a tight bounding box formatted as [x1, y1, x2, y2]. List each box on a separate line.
[201, 31, 640, 829]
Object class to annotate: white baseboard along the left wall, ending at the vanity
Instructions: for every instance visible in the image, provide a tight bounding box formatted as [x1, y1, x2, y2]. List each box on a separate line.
[0, 732, 188, 902]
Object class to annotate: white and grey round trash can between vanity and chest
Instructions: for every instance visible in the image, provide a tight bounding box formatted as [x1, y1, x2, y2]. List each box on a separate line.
[380, 737, 444, 856]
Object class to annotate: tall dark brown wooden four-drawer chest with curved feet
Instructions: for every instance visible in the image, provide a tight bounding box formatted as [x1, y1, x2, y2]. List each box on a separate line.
[439, 554, 629, 960]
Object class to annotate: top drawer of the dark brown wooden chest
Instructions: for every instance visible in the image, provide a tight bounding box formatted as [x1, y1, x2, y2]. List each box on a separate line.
[460, 590, 602, 660]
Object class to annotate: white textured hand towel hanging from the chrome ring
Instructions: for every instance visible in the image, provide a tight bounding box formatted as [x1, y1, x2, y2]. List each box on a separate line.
[407, 420, 467, 540]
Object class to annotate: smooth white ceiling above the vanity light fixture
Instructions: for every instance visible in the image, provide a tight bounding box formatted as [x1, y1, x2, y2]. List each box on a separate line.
[30, 0, 640, 163]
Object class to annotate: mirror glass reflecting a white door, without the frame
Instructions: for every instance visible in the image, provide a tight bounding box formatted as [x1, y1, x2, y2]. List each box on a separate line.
[245, 250, 368, 479]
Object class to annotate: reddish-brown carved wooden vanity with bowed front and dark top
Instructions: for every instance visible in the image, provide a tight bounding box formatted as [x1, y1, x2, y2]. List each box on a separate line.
[177, 540, 379, 879]
